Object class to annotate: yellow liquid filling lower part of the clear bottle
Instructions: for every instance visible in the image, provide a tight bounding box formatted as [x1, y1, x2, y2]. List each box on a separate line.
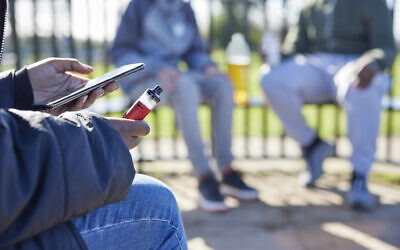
[228, 63, 248, 105]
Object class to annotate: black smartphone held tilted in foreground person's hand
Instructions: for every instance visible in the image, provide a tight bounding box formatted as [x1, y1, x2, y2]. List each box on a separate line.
[36, 63, 144, 110]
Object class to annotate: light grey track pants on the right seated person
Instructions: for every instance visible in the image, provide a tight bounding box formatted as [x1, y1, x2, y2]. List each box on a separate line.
[261, 53, 390, 176]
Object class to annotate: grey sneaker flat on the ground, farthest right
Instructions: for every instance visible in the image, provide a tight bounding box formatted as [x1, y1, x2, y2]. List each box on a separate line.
[346, 173, 379, 211]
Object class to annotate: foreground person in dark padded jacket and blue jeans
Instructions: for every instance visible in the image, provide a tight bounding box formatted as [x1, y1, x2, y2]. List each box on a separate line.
[0, 1, 187, 249]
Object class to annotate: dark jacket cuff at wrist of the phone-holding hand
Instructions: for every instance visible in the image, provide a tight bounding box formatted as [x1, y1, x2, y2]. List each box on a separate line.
[0, 68, 33, 109]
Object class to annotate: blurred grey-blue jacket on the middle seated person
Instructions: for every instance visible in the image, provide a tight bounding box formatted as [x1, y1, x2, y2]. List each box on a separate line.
[111, 0, 214, 82]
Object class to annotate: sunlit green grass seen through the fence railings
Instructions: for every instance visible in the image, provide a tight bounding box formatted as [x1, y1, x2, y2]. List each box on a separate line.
[99, 50, 400, 138]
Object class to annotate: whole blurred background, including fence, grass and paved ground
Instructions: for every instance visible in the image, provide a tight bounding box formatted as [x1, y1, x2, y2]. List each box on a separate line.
[1, 0, 400, 250]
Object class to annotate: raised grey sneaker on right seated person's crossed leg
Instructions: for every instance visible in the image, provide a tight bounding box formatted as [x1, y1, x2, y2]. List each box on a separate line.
[299, 137, 334, 187]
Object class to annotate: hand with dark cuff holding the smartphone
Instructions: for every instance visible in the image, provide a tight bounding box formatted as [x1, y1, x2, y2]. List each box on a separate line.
[0, 58, 119, 115]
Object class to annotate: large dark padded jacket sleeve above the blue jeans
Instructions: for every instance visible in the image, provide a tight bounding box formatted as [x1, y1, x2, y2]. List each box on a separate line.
[0, 109, 135, 248]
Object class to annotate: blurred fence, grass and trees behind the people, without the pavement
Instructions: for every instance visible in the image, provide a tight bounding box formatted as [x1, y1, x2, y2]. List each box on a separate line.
[1, 0, 400, 164]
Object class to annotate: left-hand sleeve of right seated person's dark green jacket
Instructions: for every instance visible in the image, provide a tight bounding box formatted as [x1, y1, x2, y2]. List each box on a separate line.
[282, 8, 309, 56]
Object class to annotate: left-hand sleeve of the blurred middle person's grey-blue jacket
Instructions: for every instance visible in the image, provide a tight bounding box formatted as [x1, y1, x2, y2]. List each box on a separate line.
[111, 0, 163, 74]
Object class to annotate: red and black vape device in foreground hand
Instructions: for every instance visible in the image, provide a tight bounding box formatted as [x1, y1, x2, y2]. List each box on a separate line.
[122, 85, 163, 120]
